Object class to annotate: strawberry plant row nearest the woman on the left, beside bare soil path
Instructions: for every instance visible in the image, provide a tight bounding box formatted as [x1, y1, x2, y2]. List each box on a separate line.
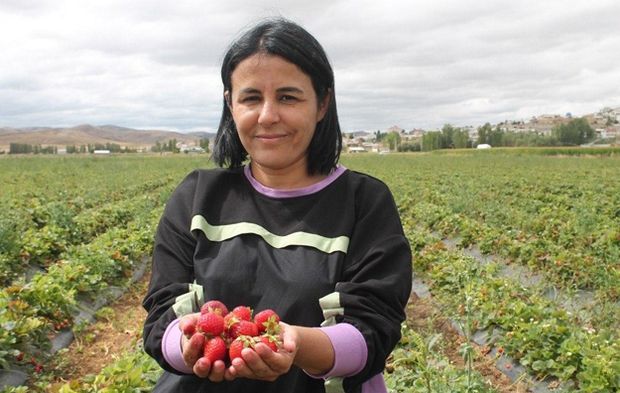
[0, 205, 161, 368]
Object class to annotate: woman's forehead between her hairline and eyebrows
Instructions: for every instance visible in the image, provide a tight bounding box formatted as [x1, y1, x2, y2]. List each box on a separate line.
[231, 53, 312, 90]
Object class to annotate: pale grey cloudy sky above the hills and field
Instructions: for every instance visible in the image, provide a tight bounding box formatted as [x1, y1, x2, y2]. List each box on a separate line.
[0, 0, 620, 131]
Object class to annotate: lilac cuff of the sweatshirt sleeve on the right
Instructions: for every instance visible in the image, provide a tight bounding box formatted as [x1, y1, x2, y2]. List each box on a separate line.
[309, 323, 368, 379]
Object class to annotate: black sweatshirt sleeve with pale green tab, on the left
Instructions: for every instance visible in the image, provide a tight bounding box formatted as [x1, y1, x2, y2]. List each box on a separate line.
[142, 172, 204, 374]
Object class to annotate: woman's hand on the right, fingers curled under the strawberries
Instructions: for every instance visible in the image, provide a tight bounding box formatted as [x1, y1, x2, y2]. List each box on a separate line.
[224, 322, 299, 381]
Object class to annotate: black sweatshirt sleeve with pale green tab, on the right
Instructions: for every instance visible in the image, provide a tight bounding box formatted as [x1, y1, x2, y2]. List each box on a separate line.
[320, 179, 412, 392]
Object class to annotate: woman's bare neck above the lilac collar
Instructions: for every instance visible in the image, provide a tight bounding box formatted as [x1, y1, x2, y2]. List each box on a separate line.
[250, 162, 326, 190]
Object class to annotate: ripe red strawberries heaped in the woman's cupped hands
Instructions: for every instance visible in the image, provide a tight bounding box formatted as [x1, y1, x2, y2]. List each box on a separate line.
[183, 300, 282, 363]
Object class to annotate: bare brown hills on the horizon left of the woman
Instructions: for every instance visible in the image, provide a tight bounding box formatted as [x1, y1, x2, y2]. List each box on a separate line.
[0, 124, 215, 151]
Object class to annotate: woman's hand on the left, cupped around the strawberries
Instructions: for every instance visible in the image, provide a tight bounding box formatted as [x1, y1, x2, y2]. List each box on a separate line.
[179, 313, 226, 382]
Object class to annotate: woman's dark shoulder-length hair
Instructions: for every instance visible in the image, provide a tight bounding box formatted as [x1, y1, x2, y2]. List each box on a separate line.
[213, 18, 342, 175]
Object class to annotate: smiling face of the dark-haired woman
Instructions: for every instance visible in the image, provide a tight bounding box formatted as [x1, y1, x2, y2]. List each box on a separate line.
[225, 54, 329, 175]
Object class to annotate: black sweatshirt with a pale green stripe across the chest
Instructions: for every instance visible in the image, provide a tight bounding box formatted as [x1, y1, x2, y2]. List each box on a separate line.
[143, 168, 411, 393]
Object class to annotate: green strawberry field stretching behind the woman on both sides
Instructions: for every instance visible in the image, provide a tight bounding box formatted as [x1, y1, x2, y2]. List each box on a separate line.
[0, 149, 620, 393]
